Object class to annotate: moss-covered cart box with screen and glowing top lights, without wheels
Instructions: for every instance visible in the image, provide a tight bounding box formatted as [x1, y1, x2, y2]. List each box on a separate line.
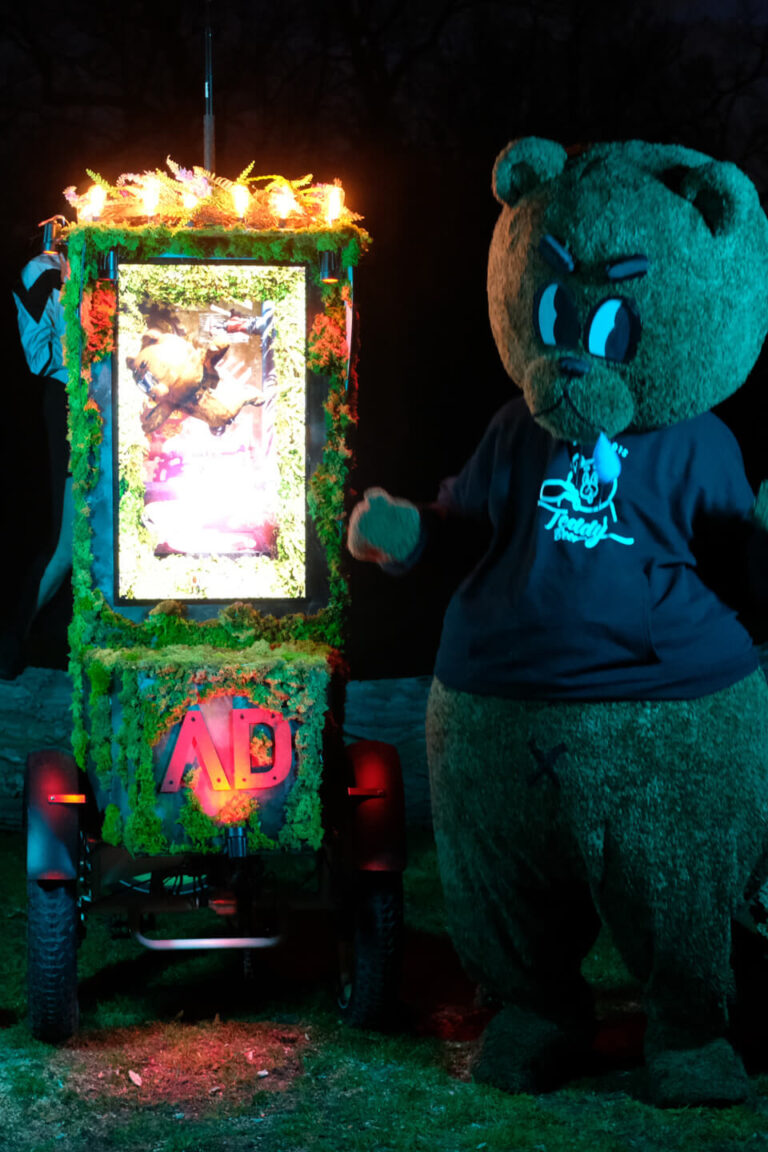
[59, 161, 370, 856]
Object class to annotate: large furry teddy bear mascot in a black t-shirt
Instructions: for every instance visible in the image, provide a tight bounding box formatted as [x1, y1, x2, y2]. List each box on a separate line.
[348, 137, 768, 1106]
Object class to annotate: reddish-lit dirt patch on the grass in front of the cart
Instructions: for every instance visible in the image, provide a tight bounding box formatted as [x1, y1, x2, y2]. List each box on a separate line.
[54, 1020, 309, 1119]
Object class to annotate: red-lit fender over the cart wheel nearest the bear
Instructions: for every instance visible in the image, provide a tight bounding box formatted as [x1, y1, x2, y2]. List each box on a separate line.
[345, 740, 406, 872]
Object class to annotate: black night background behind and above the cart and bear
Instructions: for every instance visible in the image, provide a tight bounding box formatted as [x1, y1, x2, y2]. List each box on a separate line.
[0, 0, 768, 677]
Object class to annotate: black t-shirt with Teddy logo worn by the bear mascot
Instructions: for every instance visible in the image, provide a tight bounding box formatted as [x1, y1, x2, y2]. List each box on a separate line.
[425, 399, 759, 700]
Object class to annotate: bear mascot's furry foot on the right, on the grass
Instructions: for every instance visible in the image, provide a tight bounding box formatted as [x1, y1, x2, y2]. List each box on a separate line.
[646, 1039, 752, 1108]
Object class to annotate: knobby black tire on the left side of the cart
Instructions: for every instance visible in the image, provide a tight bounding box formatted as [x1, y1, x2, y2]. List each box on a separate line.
[26, 880, 78, 1044]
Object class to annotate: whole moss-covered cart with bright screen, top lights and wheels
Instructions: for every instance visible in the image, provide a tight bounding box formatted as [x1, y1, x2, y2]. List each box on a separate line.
[25, 166, 404, 1040]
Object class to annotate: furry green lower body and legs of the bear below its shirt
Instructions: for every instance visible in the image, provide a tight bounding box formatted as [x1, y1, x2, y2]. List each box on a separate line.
[427, 672, 768, 1102]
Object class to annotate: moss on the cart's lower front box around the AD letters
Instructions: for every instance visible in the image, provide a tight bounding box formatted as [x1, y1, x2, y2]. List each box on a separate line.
[81, 641, 335, 855]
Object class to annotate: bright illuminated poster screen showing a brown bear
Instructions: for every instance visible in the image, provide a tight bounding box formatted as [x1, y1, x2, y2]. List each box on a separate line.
[113, 262, 306, 604]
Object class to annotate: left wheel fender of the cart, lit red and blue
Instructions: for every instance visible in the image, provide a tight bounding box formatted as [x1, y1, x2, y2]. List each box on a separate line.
[24, 748, 83, 880]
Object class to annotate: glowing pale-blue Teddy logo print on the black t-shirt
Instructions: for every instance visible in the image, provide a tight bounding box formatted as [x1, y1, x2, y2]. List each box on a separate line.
[539, 445, 634, 548]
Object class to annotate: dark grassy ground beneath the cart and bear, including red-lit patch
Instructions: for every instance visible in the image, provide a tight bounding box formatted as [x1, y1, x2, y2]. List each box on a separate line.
[0, 835, 768, 1152]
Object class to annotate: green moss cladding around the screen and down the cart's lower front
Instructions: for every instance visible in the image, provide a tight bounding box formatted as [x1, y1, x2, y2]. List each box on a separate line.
[63, 226, 368, 854]
